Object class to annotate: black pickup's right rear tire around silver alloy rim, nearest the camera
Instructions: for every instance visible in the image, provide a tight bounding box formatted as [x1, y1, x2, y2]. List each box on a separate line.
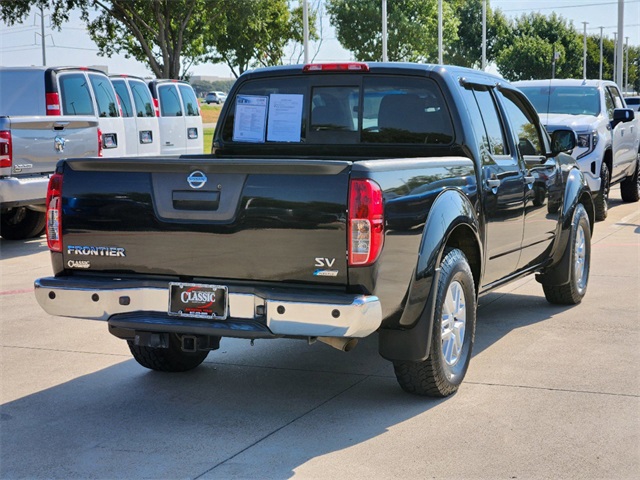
[393, 249, 476, 397]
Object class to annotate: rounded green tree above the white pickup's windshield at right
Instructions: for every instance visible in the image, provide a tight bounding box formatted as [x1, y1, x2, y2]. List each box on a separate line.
[496, 13, 582, 80]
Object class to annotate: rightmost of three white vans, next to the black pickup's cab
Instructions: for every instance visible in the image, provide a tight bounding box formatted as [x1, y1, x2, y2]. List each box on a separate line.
[149, 80, 204, 155]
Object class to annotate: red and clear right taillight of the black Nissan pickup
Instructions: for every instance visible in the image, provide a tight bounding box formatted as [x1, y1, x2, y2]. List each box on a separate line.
[349, 179, 384, 266]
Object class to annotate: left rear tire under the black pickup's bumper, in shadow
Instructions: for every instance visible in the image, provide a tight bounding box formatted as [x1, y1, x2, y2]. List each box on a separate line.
[127, 334, 209, 372]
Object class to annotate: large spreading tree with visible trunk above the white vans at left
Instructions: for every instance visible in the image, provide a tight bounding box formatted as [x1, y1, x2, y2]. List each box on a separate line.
[0, 0, 220, 78]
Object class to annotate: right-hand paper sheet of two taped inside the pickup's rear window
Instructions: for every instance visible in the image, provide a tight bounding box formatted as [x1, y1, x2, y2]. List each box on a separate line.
[267, 93, 304, 142]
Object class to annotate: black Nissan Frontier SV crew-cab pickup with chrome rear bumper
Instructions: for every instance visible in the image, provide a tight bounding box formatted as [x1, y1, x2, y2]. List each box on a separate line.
[35, 63, 594, 396]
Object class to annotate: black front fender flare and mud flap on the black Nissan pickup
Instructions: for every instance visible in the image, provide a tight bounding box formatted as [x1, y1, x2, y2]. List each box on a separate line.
[536, 168, 595, 285]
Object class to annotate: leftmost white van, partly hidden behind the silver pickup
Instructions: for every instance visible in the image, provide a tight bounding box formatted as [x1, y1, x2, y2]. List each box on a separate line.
[1, 67, 126, 157]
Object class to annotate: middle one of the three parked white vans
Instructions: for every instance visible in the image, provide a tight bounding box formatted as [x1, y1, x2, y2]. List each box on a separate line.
[109, 75, 160, 156]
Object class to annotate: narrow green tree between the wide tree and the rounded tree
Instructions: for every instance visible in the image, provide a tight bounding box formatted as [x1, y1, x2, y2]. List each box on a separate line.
[445, 0, 510, 67]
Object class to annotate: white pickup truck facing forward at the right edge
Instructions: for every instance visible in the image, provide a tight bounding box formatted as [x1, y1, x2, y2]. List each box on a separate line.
[514, 79, 640, 220]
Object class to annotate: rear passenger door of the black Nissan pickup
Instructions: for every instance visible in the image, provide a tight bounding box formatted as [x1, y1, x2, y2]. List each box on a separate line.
[463, 85, 525, 286]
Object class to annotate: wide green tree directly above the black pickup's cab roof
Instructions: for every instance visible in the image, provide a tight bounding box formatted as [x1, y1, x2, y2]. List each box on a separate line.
[326, 0, 459, 62]
